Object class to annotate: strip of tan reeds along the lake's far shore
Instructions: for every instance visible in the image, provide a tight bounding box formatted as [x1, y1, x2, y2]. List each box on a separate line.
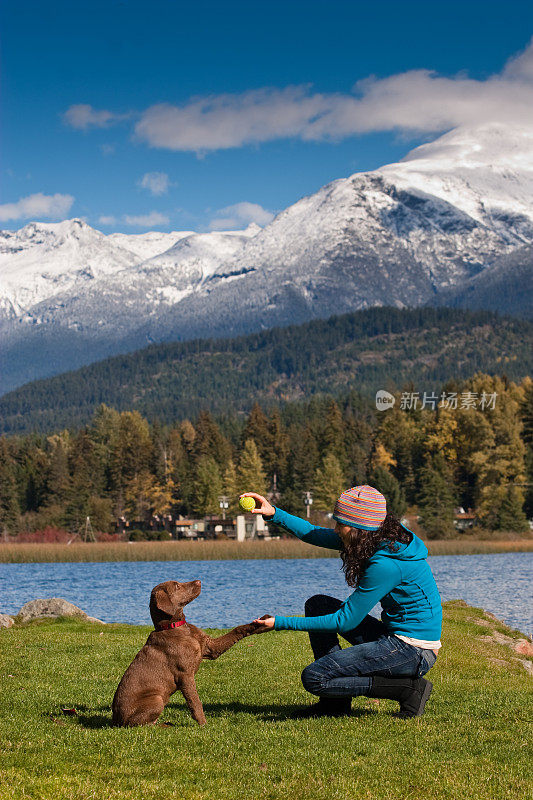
[0, 538, 533, 564]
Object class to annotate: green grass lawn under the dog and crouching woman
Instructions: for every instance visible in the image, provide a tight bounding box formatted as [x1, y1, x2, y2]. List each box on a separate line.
[0, 603, 533, 800]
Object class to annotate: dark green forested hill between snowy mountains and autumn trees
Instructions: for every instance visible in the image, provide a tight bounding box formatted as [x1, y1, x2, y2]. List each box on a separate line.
[0, 308, 533, 433]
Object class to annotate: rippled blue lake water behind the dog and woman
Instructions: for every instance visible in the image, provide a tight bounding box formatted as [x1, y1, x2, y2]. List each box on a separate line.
[0, 553, 533, 634]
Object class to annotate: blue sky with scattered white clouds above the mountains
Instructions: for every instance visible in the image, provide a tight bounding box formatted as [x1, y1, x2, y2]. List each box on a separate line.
[0, 0, 533, 233]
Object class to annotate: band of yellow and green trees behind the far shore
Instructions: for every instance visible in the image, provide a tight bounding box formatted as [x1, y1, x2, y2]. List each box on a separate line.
[0, 374, 533, 540]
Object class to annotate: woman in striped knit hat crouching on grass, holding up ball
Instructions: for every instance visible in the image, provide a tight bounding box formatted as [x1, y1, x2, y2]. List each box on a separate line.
[242, 485, 442, 717]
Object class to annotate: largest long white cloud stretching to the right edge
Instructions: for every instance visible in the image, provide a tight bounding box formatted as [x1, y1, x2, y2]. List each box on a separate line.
[135, 40, 533, 153]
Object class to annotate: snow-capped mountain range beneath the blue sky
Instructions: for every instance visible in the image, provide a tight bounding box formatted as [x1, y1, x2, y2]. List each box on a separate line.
[0, 125, 533, 390]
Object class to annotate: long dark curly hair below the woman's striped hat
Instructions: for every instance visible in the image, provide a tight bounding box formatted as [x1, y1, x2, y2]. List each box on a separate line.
[341, 513, 411, 588]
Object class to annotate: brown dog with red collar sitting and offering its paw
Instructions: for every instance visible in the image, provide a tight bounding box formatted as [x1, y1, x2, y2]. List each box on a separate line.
[113, 581, 261, 726]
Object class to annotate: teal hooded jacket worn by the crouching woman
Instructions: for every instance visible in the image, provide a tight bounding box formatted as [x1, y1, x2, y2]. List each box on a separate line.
[269, 508, 442, 641]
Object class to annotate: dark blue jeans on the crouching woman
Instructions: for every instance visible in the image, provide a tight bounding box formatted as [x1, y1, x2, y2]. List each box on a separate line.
[302, 594, 437, 697]
